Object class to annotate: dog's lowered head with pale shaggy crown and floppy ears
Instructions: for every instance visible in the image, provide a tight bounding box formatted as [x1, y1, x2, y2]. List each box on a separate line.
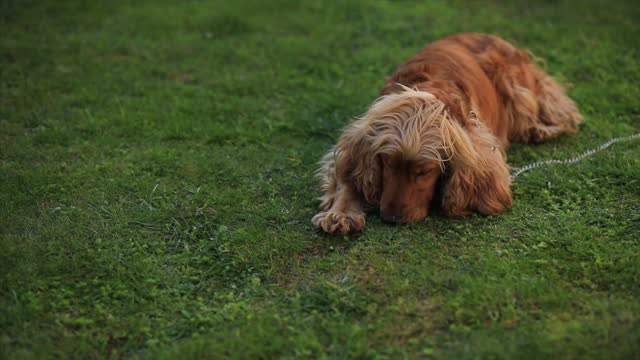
[336, 87, 511, 223]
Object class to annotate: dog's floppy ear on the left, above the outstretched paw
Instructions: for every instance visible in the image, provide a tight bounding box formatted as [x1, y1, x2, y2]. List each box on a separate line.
[334, 119, 382, 204]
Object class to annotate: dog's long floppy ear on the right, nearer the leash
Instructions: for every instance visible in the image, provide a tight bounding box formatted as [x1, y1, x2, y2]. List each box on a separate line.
[442, 115, 512, 216]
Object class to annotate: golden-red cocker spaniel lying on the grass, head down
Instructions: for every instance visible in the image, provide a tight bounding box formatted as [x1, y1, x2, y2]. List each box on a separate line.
[312, 33, 582, 234]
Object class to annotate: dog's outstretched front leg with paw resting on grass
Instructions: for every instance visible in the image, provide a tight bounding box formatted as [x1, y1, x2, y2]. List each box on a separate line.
[311, 151, 365, 235]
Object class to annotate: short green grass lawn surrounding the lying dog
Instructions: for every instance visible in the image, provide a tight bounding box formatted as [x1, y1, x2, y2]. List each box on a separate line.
[0, 0, 640, 359]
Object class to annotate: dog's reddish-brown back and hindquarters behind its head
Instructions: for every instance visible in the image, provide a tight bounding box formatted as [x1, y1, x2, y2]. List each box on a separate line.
[381, 33, 580, 146]
